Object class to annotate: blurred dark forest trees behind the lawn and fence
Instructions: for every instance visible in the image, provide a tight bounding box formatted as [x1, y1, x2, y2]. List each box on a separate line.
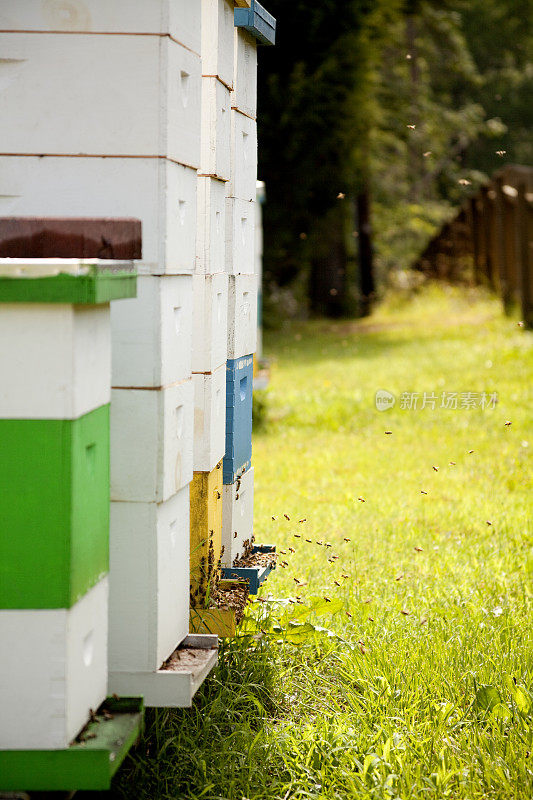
[258, 0, 533, 318]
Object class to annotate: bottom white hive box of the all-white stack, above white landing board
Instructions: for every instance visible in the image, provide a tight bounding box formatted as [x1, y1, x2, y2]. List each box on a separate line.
[109, 486, 189, 676]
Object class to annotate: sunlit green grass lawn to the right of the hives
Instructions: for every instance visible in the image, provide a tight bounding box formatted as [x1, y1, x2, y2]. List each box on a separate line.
[110, 288, 533, 800]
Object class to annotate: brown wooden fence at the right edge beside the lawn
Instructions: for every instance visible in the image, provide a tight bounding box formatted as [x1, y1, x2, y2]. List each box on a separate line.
[414, 165, 533, 328]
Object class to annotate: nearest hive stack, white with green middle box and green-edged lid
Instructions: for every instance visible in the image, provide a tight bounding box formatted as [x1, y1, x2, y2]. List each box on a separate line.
[0, 261, 135, 756]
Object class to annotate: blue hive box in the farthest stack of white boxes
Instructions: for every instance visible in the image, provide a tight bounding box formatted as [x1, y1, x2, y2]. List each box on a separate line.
[222, 356, 254, 483]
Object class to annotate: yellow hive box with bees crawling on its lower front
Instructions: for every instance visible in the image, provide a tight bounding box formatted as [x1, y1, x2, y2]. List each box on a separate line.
[190, 462, 222, 607]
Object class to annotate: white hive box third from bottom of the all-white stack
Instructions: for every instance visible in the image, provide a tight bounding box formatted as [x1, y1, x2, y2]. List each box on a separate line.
[111, 275, 193, 388]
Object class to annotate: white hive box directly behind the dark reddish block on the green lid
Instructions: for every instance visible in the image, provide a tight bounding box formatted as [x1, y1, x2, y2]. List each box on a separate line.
[0, 155, 197, 275]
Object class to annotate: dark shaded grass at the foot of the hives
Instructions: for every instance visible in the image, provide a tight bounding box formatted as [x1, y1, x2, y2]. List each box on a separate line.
[76, 637, 283, 800]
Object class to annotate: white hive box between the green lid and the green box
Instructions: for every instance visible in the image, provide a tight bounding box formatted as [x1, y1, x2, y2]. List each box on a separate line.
[0, 300, 111, 419]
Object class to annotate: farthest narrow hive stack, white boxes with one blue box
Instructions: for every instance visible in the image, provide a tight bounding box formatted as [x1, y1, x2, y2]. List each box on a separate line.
[222, 14, 257, 567]
